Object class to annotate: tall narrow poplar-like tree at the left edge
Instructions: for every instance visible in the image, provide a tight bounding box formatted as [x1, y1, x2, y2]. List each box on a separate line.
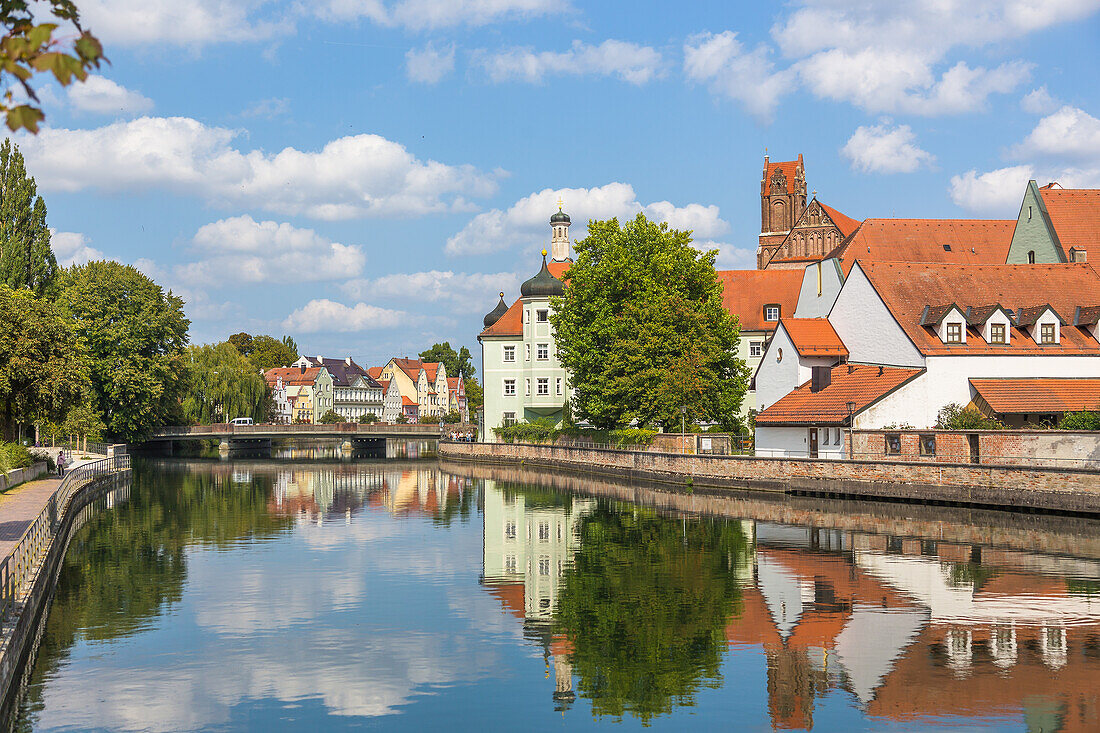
[0, 140, 57, 297]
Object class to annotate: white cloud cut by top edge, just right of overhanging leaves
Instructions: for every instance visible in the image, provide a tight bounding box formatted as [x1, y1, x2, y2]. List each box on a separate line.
[80, 0, 290, 48]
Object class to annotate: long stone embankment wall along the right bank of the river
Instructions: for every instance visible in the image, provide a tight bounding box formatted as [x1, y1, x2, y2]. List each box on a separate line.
[439, 442, 1100, 514]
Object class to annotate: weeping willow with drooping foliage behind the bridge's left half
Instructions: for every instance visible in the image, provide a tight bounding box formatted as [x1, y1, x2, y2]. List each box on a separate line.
[183, 342, 271, 425]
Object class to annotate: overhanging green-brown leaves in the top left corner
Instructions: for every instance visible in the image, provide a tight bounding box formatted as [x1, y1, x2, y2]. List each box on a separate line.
[0, 0, 107, 132]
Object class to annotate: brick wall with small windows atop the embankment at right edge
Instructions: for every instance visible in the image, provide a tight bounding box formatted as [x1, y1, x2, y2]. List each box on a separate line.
[850, 430, 1100, 471]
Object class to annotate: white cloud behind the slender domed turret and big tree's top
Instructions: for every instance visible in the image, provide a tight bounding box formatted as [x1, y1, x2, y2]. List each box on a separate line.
[446, 183, 729, 255]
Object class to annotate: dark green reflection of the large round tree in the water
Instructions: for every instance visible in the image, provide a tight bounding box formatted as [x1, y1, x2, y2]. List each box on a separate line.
[554, 501, 748, 722]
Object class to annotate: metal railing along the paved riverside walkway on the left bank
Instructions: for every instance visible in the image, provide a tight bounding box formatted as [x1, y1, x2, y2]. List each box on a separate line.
[0, 455, 130, 627]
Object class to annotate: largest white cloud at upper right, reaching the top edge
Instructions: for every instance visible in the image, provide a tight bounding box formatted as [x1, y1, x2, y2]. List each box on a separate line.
[684, 0, 1100, 120]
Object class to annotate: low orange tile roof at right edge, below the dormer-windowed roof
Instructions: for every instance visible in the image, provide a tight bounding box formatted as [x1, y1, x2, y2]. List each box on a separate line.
[970, 378, 1100, 415]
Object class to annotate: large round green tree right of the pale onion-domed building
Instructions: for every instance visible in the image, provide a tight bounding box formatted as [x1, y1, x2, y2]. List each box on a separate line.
[551, 214, 748, 429]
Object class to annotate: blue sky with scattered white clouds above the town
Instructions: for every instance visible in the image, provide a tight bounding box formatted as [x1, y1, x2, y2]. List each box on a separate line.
[18, 0, 1100, 372]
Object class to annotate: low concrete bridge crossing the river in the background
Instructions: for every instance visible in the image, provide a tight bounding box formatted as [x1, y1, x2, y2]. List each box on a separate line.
[145, 423, 450, 450]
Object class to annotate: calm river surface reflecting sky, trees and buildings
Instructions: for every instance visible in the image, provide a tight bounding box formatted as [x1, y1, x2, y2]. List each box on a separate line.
[10, 461, 1100, 732]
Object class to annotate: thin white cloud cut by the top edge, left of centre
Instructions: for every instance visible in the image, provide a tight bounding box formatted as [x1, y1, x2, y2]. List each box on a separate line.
[309, 0, 572, 31]
